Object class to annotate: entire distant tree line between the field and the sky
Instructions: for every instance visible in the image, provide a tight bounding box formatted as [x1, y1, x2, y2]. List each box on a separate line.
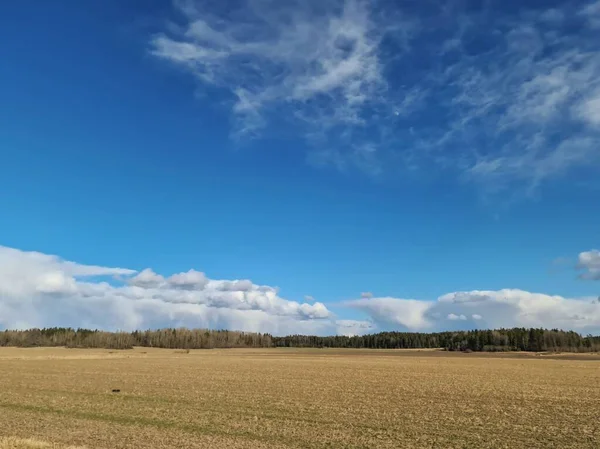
[0, 327, 600, 352]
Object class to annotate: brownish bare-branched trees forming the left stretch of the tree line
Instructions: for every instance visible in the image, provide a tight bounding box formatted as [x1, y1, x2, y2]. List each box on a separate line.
[0, 327, 273, 349]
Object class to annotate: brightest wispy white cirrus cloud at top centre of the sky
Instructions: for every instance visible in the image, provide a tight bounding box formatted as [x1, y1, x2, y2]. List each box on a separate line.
[151, 0, 394, 138]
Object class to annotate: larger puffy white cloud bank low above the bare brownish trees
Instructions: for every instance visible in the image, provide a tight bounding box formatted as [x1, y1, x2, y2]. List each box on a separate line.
[0, 246, 338, 334]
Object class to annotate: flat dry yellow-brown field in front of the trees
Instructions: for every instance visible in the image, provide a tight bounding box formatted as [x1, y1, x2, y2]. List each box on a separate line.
[0, 348, 600, 449]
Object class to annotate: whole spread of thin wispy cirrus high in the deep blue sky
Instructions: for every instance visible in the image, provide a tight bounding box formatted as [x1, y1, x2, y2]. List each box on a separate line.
[150, 0, 600, 193]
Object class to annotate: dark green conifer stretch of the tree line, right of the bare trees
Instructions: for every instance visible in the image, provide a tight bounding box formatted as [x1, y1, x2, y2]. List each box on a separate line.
[272, 328, 600, 352]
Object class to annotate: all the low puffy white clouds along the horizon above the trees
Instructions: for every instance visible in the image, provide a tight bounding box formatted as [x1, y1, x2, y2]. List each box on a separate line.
[0, 246, 600, 335]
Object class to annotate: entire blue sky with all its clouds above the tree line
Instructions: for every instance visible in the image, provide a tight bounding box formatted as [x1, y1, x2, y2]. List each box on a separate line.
[0, 0, 600, 335]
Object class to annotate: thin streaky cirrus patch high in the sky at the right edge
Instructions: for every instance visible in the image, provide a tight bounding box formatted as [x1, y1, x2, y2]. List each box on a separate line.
[453, 18, 600, 194]
